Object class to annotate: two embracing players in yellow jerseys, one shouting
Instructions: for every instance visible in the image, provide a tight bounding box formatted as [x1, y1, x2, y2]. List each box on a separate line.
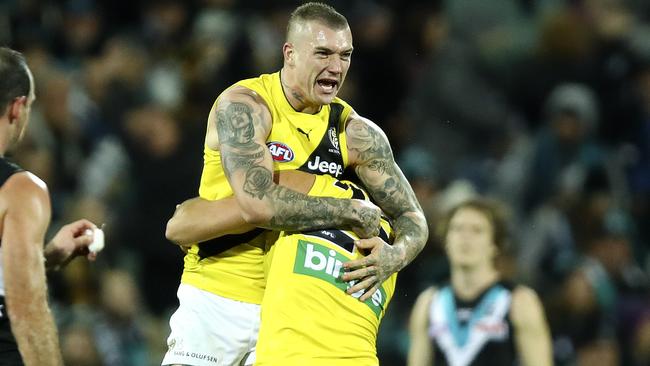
[162, 3, 428, 366]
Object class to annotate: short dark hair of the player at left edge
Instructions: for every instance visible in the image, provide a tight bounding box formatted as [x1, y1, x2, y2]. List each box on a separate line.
[0, 47, 30, 113]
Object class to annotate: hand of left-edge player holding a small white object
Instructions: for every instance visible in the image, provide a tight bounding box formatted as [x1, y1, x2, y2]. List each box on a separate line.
[46, 219, 97, 266]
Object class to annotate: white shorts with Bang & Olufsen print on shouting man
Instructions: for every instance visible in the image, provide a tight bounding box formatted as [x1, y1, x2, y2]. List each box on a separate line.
[162, 283, 260, 366]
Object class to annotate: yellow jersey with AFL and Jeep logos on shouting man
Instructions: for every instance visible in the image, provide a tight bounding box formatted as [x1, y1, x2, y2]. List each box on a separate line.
[181, 72, 352, 304]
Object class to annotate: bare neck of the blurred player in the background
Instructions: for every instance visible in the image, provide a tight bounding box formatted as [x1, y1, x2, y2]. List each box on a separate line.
[451, 266, 499, 301]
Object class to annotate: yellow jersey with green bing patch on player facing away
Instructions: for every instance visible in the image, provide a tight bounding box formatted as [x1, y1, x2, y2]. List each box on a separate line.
[255, 176, 397, 366]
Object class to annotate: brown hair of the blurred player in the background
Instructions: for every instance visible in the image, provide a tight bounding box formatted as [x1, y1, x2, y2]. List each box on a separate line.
[438, 197, 509, 252]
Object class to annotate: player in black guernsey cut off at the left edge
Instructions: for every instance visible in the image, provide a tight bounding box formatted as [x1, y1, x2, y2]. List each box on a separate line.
[0, 47, 95, 366]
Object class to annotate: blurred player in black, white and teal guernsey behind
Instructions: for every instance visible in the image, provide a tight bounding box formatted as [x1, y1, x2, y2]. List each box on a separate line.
[408, 199, 552, 366]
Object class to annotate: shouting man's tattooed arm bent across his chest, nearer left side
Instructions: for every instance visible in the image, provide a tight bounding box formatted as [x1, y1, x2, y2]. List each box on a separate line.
[212, 90, 380, 237]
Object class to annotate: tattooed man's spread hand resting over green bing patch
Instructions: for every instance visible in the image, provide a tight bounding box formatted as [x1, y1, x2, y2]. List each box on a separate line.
[342, 237, 405, 301]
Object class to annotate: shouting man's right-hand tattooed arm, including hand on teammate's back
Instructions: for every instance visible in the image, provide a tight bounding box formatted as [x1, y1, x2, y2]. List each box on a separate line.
[343, 115, 429, 301]
